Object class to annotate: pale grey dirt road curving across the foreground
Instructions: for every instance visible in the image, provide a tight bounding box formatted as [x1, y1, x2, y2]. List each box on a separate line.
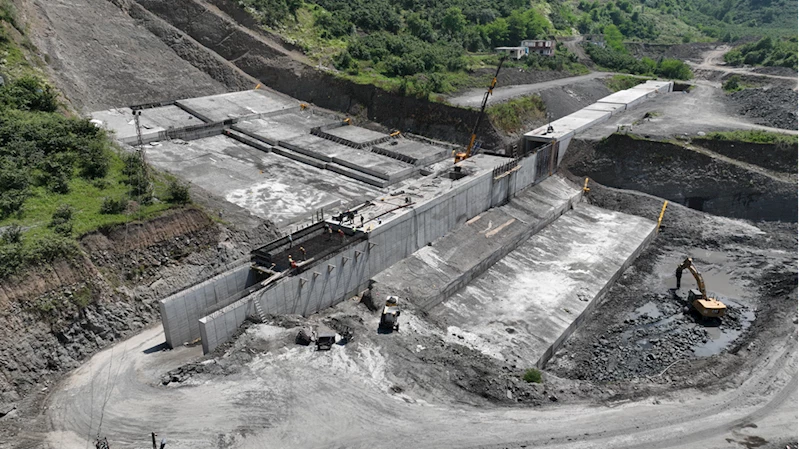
[29, 312, 797, 449]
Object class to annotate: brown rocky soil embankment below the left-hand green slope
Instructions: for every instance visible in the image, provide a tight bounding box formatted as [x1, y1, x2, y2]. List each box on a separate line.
[0, 208, 275, 433]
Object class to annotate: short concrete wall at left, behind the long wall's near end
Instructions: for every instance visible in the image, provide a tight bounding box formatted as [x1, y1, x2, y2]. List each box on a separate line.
[159, 264, 256, 348]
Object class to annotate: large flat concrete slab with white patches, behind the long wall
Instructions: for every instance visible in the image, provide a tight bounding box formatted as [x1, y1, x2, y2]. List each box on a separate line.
[147, 135, 377, 226]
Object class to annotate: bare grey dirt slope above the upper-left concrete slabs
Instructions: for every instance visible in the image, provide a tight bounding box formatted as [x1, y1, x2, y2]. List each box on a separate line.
[20, 0, 228, 113]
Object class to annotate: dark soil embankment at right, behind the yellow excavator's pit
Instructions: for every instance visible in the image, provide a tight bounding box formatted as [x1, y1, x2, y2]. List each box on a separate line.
[565, 134, 796, 222]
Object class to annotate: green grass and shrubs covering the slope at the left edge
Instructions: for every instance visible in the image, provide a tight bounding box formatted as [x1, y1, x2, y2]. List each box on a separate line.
[0, 8, 181, 278]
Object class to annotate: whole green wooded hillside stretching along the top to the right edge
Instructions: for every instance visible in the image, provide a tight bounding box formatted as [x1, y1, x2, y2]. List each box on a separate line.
[237, 0, 795, 93]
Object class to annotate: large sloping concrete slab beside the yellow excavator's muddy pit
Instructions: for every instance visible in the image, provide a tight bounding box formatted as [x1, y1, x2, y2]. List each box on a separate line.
[430, 203, 656, 367]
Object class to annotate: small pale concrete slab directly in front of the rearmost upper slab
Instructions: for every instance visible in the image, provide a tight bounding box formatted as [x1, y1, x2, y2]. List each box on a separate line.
[233, 112, 336, 145]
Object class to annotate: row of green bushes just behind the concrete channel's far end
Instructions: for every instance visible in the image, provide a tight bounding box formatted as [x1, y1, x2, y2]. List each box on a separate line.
[585, 44, 694, 80]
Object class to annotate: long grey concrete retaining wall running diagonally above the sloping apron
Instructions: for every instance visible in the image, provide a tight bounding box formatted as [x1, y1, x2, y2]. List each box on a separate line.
[199, 152, 552, 353]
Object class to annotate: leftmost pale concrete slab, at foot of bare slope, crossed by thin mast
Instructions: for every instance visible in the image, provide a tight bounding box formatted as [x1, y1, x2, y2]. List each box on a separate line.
[92, 105, 203, 141]
